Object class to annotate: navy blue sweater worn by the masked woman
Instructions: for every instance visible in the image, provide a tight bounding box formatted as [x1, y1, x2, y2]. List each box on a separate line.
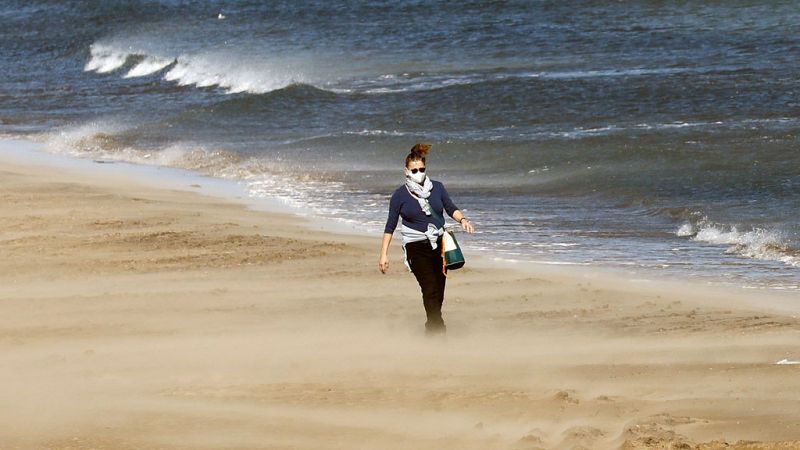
[383, 180, 458, 234]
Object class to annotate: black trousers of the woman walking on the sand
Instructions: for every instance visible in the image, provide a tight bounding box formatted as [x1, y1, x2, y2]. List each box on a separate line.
[406, 238, 447, 334]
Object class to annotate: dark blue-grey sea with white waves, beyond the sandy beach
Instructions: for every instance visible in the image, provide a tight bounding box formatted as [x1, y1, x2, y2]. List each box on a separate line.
[0, 0, 800, 289]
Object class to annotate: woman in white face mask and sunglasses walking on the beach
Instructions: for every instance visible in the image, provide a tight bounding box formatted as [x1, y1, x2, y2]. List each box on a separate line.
[378, 144, 475, 334]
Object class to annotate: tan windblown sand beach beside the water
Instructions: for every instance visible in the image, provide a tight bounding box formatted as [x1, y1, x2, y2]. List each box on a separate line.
[0, 147, 800, 449]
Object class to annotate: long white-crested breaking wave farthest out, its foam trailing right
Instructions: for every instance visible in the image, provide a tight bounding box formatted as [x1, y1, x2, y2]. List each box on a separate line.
[84, 38, 764, 99]
